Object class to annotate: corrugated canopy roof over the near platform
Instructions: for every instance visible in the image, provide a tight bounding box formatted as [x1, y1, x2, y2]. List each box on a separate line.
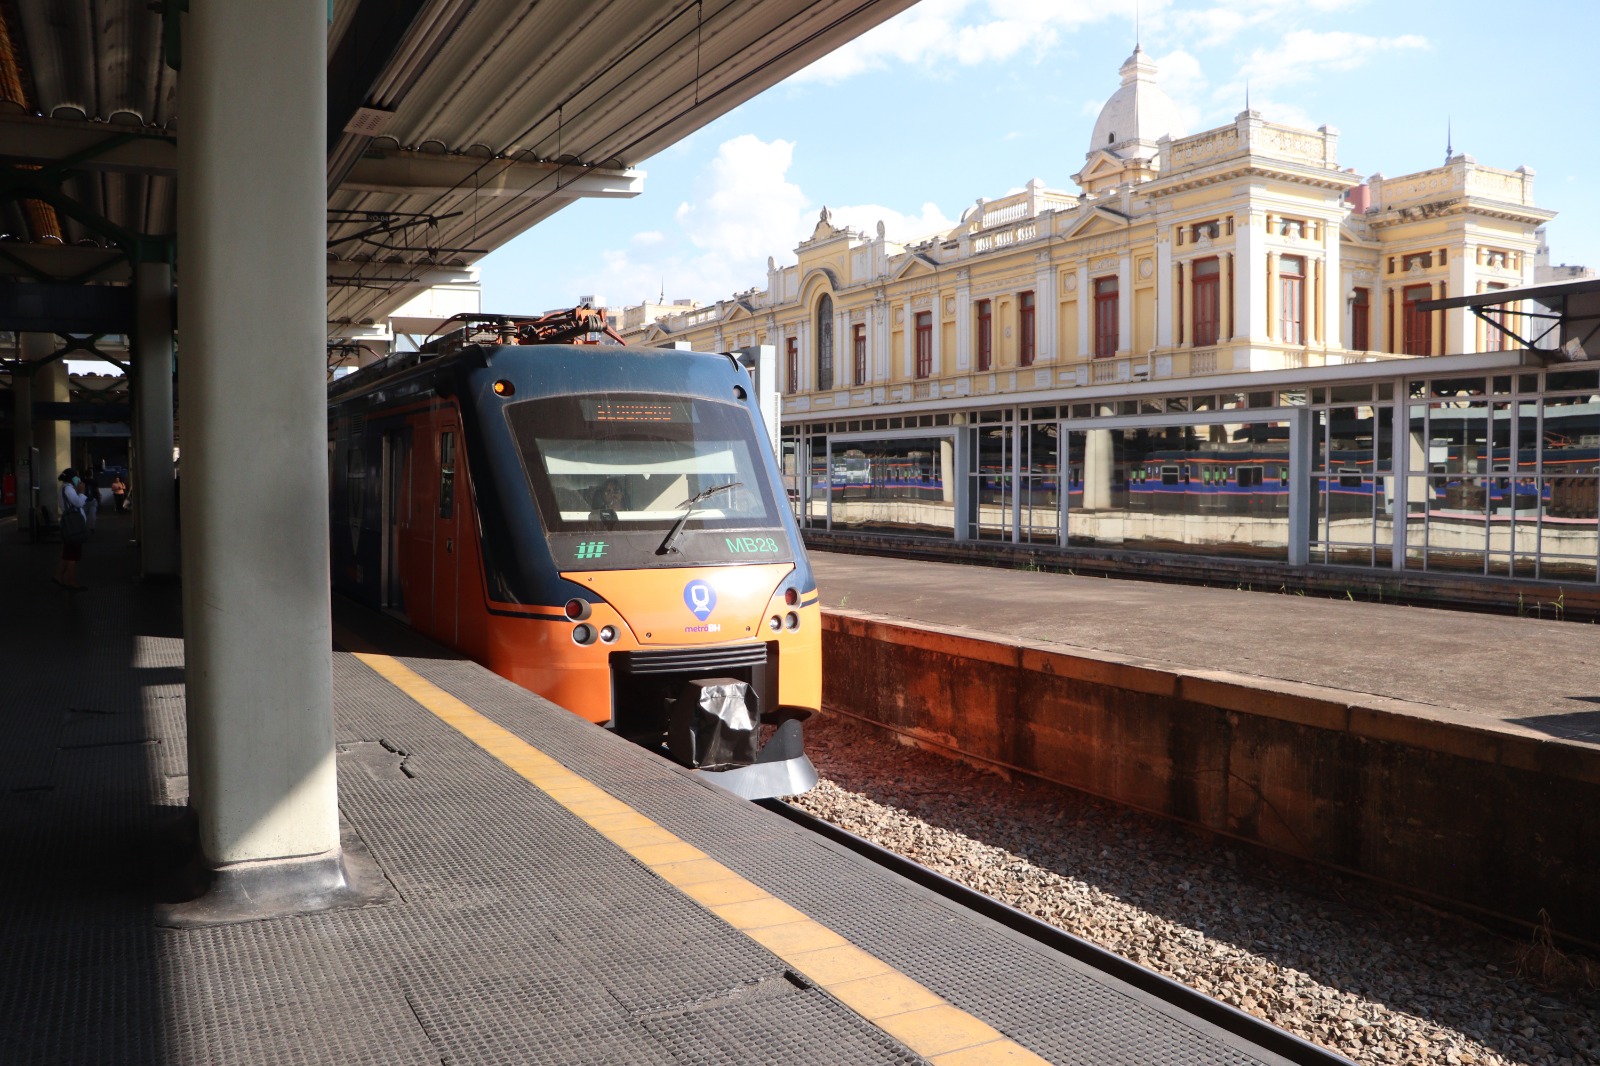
[0, 0, 914, 338]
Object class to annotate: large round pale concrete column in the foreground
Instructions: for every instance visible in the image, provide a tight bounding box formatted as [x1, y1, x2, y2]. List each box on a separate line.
[178, 0, 339, 877]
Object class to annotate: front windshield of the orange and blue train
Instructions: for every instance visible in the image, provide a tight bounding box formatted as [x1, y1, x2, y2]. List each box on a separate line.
[506, 392, 781, 533]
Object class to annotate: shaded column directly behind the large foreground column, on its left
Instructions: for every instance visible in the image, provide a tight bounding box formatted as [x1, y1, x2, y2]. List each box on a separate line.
[133, 262, 179, 578]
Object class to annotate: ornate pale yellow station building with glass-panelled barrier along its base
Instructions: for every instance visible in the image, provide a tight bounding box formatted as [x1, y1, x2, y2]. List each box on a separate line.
[630, 48, 1600, 583]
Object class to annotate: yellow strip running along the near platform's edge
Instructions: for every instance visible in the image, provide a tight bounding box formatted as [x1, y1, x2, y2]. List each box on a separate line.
[355, 651, 1046, 1066]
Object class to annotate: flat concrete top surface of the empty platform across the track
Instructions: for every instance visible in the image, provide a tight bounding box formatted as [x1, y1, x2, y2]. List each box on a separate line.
[811, 552, 1600, 754]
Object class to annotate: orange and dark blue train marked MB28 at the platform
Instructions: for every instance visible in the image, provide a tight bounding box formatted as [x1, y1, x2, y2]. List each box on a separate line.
[328, 309, 821, 799]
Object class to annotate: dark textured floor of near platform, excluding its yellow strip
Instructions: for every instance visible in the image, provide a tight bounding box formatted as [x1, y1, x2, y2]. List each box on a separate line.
[0, 517, 1299, 1066]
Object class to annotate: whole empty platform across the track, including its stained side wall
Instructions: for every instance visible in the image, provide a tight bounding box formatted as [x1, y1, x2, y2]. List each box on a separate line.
[811, 552, 1600, 943]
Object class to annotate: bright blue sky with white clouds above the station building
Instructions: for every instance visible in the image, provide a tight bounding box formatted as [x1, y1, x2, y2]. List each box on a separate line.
[482, 0, 1600, 312]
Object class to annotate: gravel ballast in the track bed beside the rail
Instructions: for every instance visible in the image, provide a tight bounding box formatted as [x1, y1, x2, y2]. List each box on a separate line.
[794, 714, 1600, 1066]
